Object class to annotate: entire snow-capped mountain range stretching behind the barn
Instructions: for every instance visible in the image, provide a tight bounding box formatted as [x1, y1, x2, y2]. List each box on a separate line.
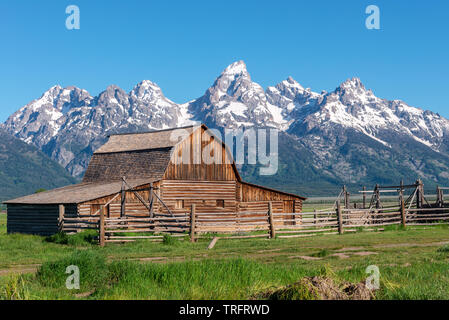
[3, 61, 449, 195]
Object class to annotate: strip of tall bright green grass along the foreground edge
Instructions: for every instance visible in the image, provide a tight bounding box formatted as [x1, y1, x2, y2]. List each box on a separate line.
[0, 249, 449, 300]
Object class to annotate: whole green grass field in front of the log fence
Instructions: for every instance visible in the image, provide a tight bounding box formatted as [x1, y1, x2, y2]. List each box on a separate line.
[0, 210, 449, 299]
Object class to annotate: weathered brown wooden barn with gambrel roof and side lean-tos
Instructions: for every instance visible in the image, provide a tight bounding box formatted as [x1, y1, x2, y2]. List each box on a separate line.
[4, 125, 305, 235]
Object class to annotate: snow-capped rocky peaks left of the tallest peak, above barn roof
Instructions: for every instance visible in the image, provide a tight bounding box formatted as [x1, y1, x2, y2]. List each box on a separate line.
[3, 81, 192, 176]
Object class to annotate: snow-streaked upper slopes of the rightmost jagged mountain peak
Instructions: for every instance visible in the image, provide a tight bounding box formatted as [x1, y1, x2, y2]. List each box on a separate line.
[290, 78, 449, 151]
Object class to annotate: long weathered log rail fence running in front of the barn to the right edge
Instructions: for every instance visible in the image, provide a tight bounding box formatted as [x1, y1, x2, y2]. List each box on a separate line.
[60, 201, 449, 248]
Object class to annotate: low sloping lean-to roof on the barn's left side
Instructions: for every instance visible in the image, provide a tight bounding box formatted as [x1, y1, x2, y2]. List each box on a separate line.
[3, 178, 154, 204]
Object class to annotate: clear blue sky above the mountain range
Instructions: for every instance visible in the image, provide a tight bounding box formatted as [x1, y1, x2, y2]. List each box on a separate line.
[0, 0, 449, 121]
